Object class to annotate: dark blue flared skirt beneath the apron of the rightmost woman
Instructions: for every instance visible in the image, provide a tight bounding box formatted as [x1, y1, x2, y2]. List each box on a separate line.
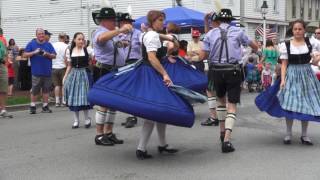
[255, 79, 320, 122]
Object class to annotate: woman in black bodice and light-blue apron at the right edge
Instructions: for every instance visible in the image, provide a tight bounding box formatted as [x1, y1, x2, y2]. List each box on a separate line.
[256, 20, 320, 145]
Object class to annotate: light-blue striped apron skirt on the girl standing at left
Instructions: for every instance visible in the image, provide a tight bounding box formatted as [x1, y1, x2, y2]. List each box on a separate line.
[63, 68, 93, 111]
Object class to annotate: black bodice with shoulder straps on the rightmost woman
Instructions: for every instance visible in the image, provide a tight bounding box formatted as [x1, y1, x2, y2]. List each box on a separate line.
[285, 37, 312, 65]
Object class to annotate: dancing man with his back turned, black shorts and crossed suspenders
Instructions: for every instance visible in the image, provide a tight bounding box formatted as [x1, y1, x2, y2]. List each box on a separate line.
[201, 9, 258, 153]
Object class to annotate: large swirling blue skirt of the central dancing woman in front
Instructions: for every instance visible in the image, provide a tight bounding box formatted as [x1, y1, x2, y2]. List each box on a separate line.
[88, 63, 195, 127]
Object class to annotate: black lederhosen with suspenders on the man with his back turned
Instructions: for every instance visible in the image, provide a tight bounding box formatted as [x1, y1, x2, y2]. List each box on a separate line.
[208, 26, 243, 103]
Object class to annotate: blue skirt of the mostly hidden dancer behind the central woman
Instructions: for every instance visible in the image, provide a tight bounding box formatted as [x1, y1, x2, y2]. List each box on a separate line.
[161, 57, 208, 92]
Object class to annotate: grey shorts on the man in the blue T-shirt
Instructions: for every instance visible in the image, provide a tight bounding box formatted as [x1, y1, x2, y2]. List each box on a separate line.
[31, 75, 52, 96]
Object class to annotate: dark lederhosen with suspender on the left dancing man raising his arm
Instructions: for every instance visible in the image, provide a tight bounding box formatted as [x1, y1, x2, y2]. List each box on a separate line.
[93, 40, 118, 82]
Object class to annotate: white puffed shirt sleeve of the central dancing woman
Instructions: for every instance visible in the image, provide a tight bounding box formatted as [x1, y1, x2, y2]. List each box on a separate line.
[143, 31, 161, 52]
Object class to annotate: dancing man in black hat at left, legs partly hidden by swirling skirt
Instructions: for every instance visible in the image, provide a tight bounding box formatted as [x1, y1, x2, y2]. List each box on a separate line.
[92, 7, 132, 146]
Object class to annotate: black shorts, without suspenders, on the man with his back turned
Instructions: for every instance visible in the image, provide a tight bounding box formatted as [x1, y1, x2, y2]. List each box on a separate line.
[209, 67, 243, 104]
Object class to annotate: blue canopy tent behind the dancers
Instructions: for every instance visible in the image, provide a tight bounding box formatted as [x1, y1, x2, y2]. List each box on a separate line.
[134, 6, 204, 29]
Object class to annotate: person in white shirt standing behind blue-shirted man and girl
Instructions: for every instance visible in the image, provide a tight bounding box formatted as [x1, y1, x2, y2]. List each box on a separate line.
[52, 33, 68, 107]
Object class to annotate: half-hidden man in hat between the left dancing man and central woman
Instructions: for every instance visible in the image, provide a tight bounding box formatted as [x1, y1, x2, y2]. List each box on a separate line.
[118, 13, 142, 128]
